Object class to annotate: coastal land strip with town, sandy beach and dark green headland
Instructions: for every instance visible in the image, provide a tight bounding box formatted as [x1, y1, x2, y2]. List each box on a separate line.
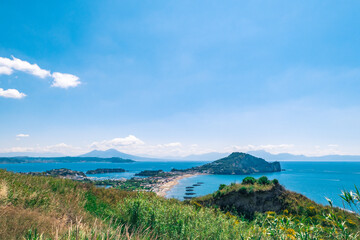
[20, 152, 281, 199]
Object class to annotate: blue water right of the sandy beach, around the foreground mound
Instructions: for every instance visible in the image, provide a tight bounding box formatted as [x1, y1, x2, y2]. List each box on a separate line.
[167, 162, 360, 207]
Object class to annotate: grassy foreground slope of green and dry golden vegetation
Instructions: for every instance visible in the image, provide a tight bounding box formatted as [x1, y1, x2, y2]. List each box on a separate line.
[0, 170, 359, 239]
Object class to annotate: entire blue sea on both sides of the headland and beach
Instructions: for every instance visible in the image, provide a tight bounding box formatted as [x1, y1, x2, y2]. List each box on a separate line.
[0, 161, 360, 208]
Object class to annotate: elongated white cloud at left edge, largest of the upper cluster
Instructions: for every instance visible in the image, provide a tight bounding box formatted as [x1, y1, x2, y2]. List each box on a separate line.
[0, 56, 50, 78]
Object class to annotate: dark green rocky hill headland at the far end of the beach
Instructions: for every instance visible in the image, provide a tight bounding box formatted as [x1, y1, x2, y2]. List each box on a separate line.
[193, 152, 281, 175]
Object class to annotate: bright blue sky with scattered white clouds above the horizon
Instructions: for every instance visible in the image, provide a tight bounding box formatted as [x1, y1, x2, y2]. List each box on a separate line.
[0, 0, 360, 156]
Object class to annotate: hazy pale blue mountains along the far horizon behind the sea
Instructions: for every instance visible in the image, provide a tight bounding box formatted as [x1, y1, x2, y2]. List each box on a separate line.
[0, 149, 360, 161]
